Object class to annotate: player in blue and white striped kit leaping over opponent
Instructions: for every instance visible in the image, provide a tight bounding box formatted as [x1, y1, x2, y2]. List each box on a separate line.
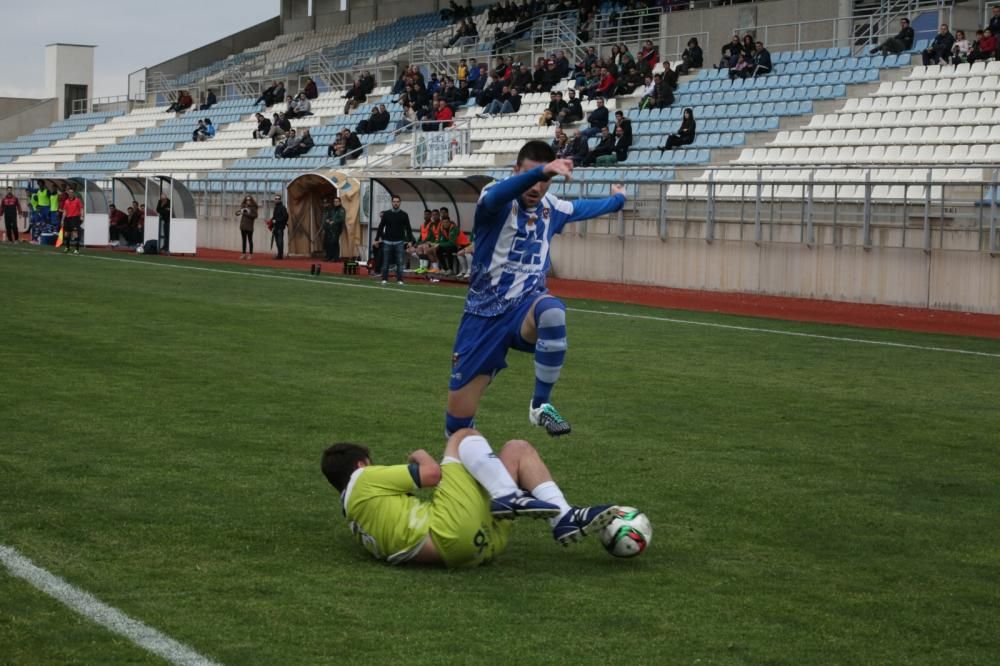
[445, 141, 625, 436]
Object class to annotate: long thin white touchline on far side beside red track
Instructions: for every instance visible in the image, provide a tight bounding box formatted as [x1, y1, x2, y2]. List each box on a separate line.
[7, 245, 1000, 358]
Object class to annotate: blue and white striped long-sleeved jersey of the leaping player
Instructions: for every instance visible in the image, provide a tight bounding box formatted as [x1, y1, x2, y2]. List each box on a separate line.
[465, 166, 625, 317]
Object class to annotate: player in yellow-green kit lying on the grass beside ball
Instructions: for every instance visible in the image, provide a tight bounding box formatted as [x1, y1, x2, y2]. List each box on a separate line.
[322, 428, 616, 567]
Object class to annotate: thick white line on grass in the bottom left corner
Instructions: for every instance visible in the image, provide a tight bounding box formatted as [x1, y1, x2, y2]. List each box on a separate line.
[0, 546, 218, 666]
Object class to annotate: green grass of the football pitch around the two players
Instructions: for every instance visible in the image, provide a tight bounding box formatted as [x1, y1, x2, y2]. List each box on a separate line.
[0, 245, 1000, 664]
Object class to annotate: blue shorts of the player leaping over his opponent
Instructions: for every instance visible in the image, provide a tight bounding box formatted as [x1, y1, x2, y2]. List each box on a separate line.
[448, 294, 544, 391]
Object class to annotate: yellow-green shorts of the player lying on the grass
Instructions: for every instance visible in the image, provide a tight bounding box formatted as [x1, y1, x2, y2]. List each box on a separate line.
[429, 460, 512, 567]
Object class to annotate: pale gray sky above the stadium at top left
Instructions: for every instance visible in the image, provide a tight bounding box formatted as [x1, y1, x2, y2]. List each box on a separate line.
[0, 0, 281, 97]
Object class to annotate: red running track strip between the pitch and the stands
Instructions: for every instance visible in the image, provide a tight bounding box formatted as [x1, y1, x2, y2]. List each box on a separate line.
[115, 250, 1000, 339]
